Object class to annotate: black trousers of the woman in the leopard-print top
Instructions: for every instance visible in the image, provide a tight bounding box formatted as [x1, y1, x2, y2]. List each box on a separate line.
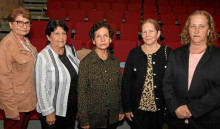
[131, 110, 164, 129]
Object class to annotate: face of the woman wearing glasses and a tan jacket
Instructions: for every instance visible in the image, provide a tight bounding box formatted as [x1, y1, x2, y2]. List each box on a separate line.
[9, 15, 31, 37]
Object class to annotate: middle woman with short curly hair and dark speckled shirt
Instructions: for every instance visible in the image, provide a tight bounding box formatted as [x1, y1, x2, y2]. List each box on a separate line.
[77, 22, 124, 129]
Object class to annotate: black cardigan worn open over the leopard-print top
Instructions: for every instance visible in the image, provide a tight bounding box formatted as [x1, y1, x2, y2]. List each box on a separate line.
[122, 45, 172, 112]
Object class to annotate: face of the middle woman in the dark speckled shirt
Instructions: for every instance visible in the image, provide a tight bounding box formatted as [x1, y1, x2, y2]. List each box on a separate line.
[92, 27, 112, 50]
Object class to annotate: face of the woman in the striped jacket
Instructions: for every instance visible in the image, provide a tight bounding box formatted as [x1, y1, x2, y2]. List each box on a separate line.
[47, 26, 67, 49]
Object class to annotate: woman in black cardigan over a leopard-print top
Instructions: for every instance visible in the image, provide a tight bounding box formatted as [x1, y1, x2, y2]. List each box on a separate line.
[122, 19, 171, 129]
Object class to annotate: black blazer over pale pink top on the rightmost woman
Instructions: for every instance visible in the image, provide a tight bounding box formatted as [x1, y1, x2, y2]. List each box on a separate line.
[163, 45, 220, 129]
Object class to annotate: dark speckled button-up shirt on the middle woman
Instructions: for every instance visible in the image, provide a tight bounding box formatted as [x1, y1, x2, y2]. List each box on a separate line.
[77, 48, 123, 128]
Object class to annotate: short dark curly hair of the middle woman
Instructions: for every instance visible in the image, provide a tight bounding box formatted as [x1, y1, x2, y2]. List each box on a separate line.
[89, 21, 114, 40]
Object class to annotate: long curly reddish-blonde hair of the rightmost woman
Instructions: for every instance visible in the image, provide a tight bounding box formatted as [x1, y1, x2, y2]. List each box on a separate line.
[181, 10, 216, 45]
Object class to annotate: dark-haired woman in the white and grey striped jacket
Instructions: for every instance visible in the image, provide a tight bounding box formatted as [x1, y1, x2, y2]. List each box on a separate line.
[34, 20, 79, 129]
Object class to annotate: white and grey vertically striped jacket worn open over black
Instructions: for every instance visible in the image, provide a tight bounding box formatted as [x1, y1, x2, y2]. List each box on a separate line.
[34, 45, 79, 117]
